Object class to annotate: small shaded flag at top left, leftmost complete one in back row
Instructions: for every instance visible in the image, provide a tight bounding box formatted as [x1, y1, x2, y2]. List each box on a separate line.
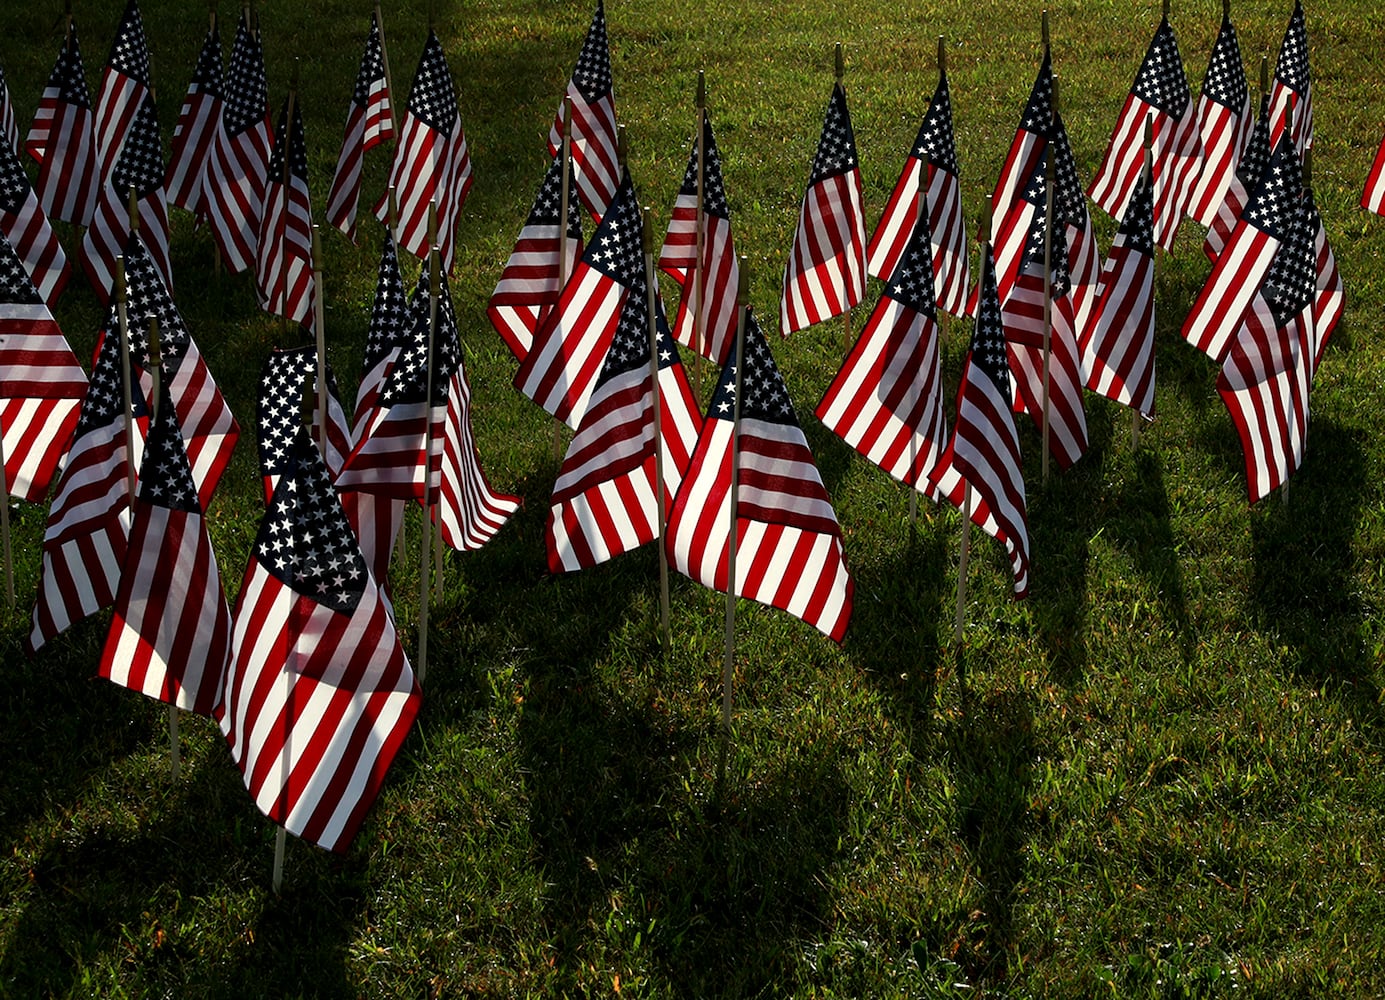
[24, 26, 98, 226]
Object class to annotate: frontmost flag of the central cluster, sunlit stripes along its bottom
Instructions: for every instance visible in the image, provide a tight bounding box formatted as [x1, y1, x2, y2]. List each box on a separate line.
[665, 314, 853, 643]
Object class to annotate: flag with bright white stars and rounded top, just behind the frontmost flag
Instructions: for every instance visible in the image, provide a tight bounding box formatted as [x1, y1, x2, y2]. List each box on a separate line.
[255, 346, 350, 503]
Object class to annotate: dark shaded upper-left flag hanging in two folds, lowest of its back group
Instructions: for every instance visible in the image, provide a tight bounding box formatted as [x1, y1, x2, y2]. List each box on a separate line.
[82, 93, 173, 302]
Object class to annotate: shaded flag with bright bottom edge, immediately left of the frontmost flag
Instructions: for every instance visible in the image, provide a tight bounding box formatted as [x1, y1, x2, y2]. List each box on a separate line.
[97, 376, 231, 715]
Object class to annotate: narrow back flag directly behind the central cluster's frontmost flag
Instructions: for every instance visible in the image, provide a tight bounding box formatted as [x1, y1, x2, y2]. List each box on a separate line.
[659, 111, 741, 364]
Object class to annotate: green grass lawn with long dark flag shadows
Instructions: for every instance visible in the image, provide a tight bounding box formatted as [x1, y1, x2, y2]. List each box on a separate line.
[0, 0, 1385, 1000]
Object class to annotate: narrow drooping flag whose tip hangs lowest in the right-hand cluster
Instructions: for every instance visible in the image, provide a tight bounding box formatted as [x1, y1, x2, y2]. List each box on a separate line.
[931, 247, 1029, 598]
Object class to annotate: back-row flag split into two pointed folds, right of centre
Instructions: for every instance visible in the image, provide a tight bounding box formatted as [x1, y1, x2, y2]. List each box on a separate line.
[866, 62, 971, 319]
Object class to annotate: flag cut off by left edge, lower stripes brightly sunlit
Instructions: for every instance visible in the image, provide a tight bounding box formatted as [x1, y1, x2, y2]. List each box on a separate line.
[0, 233, 87, 503]
